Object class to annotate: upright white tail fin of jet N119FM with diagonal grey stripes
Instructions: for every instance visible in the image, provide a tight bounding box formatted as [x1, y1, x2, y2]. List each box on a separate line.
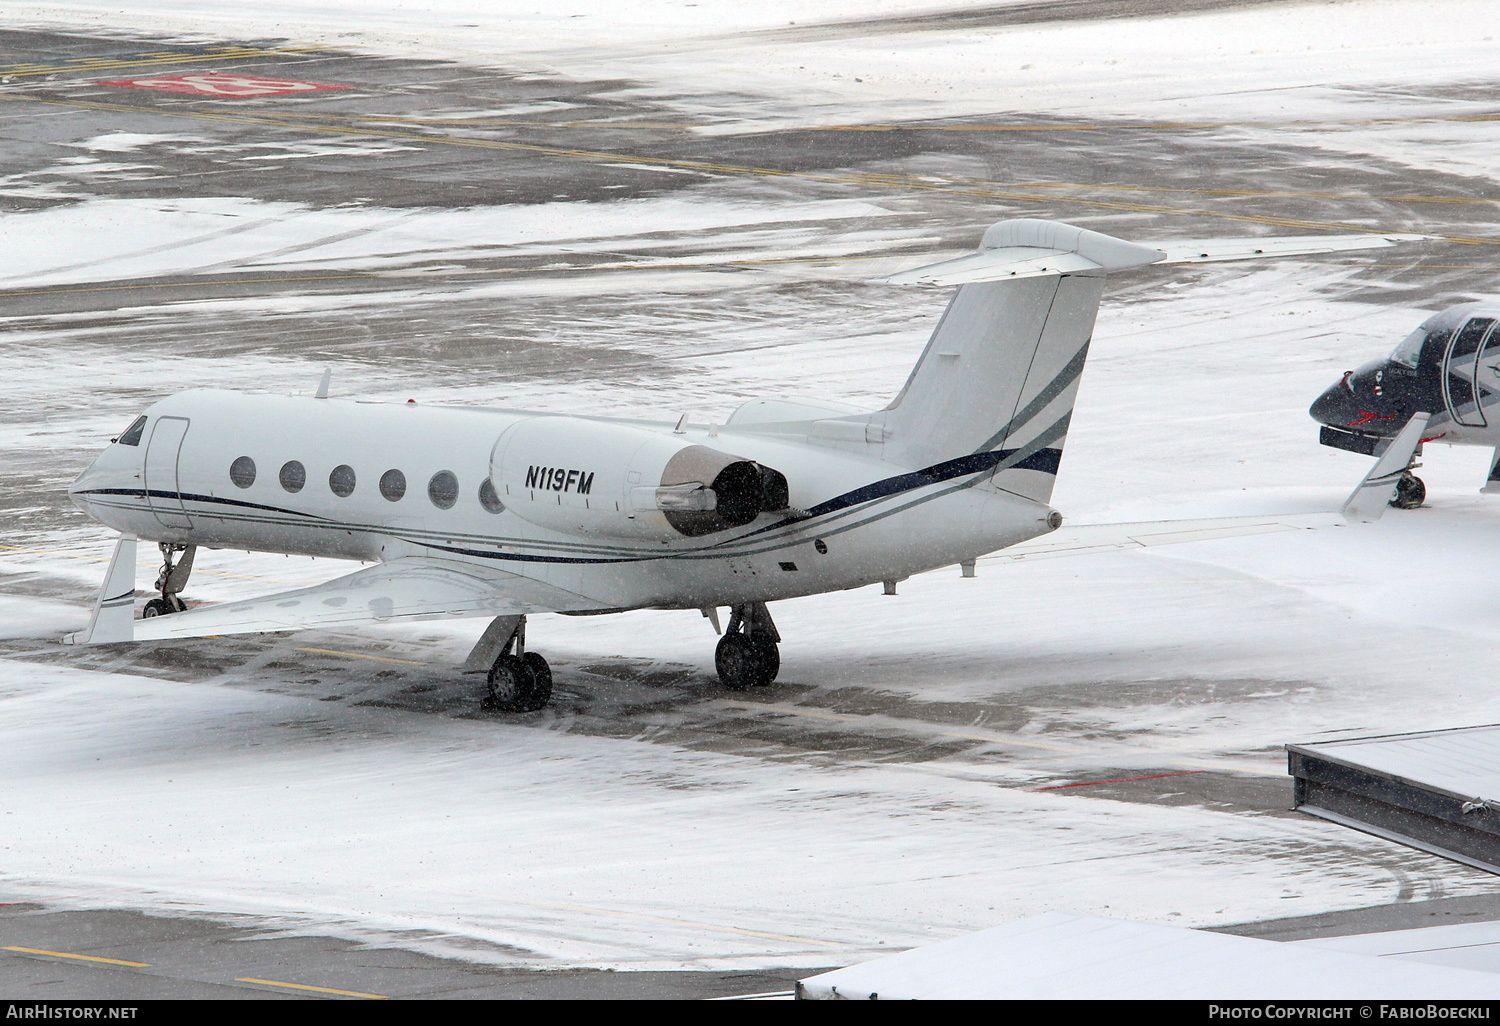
[876, 221, 1163, 503]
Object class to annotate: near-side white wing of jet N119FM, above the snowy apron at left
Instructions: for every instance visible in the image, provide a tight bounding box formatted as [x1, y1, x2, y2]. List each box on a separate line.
[122, 558, 603, 641]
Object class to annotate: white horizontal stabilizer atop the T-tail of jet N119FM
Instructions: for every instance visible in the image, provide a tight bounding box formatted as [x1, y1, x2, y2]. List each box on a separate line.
[881, 218, 1428, 287]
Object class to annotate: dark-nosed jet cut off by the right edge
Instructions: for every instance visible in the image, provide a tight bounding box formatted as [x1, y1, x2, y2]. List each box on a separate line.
[1308, 303, 1500, 509]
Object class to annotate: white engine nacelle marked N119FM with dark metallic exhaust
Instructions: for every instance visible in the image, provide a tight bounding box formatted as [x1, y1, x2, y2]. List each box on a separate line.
[489, 417, 788, 542]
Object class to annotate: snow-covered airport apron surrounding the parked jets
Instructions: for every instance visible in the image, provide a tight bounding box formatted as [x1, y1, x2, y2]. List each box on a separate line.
[0, 0, 1500, 968]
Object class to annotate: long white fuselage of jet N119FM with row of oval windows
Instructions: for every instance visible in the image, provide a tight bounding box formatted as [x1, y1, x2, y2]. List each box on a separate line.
[69, 390, 1058, 609]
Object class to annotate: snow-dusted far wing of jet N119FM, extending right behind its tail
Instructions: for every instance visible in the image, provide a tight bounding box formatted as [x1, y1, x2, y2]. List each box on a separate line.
[980, 513, 1349, 563]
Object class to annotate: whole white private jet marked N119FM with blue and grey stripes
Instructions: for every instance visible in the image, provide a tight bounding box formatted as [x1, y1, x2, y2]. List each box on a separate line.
[69, 221, 1425, 710]
